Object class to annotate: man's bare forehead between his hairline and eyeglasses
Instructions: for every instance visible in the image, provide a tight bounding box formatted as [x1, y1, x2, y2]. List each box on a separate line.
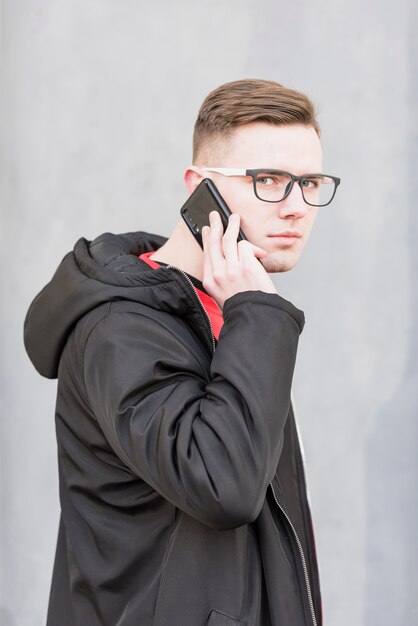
[221, 123, 322, 174]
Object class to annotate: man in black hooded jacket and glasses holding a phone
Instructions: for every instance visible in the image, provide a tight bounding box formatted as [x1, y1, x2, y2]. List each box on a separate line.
[25, 80, 339, 626]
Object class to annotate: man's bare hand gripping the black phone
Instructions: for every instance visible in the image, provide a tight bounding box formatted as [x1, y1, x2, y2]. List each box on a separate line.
[202, 211, 277, 309]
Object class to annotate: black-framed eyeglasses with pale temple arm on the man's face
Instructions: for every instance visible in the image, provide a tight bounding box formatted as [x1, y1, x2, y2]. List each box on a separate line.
[200, 167, 341, 206]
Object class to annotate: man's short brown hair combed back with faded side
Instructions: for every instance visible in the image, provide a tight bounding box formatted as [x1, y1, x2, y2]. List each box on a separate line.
[193, 79, 320, 163]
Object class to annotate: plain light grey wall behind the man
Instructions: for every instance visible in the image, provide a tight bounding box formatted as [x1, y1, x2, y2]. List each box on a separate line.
[0, 0, 418, 626]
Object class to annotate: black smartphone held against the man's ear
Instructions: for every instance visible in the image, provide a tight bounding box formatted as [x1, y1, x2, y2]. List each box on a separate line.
[180, 178, 247, 248]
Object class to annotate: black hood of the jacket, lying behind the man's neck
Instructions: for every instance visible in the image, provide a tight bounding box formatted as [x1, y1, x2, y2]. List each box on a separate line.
[24, 232, 212, 378]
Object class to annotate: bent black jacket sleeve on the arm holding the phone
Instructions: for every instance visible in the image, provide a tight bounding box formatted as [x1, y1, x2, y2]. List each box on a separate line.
[84, 292, 303, 528]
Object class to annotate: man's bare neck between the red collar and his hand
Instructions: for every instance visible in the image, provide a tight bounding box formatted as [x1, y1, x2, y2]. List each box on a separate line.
[151, 220, 203, 280]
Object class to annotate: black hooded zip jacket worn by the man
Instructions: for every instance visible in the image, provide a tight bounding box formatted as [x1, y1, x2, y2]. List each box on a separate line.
[25, 233, 321, 626]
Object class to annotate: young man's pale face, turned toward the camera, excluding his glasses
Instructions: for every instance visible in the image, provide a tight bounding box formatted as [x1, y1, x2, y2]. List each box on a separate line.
[201, 123, 322, 272]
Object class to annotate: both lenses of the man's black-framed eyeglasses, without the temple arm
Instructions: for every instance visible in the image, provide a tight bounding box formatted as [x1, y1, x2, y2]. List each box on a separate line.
[255, 172, 335, 206]
